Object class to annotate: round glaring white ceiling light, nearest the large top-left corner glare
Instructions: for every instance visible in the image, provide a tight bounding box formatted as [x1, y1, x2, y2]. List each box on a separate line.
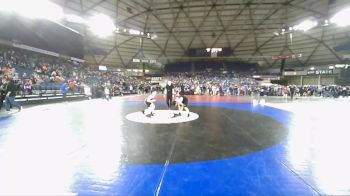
[88, 14, 116, 37]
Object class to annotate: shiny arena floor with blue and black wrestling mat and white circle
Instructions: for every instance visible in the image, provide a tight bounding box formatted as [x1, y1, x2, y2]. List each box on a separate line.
[0, 96, 350, 195]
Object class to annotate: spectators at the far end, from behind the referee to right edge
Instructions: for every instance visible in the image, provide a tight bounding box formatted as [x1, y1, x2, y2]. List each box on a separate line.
[165, 72, 350, 98]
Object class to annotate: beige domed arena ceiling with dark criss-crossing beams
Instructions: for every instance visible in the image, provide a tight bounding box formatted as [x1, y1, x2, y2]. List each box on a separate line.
[53, 0, 350, 68]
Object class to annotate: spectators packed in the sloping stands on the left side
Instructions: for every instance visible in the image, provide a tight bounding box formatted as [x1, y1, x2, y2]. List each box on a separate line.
[0, 46, 153, 96]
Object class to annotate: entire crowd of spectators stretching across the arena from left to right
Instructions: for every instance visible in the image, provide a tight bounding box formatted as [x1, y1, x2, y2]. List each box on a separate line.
[0, 46, 350, 105]
